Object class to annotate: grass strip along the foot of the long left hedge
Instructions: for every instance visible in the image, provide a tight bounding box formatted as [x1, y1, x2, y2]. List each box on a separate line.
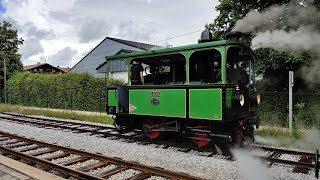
[0, 104, 113, 124]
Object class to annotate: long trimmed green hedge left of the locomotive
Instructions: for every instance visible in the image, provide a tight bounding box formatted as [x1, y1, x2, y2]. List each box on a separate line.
[7, 72, 124, 111]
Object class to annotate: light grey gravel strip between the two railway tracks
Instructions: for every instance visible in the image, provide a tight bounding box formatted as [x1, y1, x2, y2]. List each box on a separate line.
[0, 121, 315, 180]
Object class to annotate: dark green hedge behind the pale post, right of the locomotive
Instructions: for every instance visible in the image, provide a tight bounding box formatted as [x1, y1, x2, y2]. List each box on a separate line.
[257, 91, 320, 129]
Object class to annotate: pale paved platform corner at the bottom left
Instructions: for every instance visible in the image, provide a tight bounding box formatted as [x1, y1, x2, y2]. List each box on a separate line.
[0, 155, 63, 180]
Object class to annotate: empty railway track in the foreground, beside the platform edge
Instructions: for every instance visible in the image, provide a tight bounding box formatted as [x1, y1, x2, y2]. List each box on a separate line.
[0, 131, 200, 180]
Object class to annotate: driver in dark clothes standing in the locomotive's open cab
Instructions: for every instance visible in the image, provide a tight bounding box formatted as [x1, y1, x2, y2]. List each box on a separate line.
[130, 60, 144, 85]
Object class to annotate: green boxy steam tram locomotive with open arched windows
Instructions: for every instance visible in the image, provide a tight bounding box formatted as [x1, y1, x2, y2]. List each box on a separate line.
[106, 31, 260, 146]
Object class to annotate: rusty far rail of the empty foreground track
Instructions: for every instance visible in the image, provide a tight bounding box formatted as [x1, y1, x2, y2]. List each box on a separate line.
[0, 131, 201, 180]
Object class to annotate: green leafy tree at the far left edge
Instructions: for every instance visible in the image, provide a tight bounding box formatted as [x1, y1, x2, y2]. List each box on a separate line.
[0, 21, 23, 95]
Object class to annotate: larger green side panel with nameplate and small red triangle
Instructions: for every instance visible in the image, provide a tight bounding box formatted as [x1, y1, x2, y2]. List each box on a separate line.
[129, 89, 186, 118]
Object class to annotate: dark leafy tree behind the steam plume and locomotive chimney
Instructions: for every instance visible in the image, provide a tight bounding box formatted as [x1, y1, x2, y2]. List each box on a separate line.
[206, 0, 320, 90]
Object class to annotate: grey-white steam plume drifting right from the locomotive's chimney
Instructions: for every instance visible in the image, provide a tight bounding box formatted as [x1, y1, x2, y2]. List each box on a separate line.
[233, 0, 320, 83]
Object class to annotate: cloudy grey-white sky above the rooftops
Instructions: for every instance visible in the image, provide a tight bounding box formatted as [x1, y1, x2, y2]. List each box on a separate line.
[0, 0, 218, 67]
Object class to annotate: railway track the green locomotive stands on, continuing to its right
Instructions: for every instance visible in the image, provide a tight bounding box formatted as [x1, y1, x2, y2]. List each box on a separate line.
[0, 113, 319, 177]
